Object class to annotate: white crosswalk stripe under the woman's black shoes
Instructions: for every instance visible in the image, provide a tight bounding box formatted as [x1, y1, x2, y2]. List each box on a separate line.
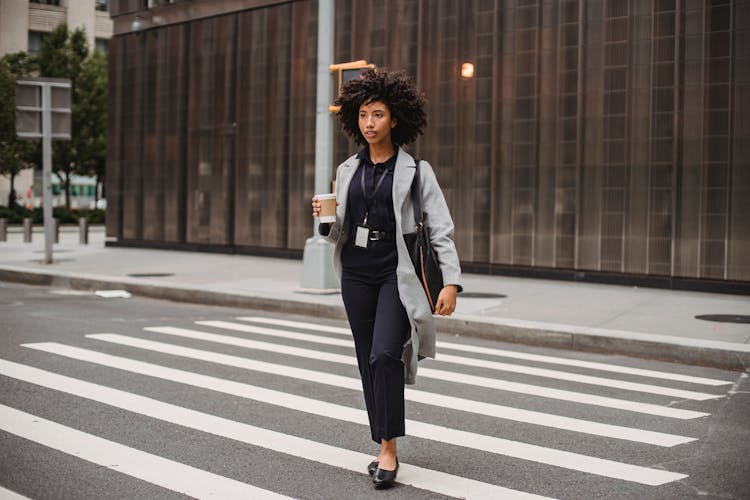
[0, 358, 545, 499]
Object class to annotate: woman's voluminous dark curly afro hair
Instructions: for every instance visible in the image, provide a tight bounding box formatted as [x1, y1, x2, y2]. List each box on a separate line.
[334, 69, 427, 146]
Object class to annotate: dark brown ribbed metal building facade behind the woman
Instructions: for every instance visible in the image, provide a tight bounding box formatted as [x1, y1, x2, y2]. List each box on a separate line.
[107, 0, 750, 290]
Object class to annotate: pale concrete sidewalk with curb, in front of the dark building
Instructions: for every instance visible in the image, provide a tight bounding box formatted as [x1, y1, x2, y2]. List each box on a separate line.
[0, 227, 750, 370]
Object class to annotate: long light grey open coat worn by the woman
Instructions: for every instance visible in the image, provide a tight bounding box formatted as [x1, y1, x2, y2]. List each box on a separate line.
[320, 148, 461, 384]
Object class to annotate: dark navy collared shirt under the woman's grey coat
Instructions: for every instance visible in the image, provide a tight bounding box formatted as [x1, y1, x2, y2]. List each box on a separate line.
[341, 147, 398, 273]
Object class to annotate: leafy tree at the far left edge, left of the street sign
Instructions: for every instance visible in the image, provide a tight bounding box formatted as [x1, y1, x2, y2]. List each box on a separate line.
[0, 52, 36, 208]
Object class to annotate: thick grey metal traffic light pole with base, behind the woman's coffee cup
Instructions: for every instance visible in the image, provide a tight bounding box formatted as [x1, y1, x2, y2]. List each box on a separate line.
[302, 0, 340, 293]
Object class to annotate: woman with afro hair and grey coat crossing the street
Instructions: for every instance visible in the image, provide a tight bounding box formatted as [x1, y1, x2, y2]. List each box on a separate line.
[312, 70, 461, 488]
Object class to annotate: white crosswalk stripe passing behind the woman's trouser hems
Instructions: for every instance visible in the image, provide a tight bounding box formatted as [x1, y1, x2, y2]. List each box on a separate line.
[16, 344, 687, 486]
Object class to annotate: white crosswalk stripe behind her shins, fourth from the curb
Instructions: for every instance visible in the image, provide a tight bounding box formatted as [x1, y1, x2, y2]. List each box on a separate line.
[79, 336, 696, 447]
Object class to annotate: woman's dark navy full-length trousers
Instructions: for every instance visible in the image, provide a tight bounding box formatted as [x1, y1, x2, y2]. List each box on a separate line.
[341, 270, 411, 444]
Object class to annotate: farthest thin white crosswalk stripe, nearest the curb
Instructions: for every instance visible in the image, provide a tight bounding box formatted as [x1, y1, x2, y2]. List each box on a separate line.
[237, 316, 733, 386]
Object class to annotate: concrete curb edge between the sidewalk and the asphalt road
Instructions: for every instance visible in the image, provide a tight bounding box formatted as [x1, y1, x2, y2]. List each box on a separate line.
[0, 266, 750, 371]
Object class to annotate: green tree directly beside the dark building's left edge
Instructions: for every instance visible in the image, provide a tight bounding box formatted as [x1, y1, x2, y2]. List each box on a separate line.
[73, 51, 108, 201]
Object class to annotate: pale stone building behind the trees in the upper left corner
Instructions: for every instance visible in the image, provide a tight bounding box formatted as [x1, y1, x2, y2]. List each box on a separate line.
[0, 0, 112, 206]
